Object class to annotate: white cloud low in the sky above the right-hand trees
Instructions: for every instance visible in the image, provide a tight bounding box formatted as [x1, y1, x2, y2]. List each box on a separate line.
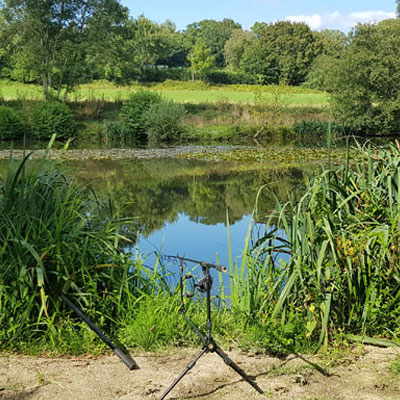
[285, 11, 396, 31]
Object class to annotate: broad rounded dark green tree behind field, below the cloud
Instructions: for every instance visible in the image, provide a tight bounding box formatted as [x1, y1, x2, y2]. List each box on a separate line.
[241, 21, 315, 85]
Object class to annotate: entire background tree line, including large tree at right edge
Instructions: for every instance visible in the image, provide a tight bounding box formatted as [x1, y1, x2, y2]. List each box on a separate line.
[0, 0, 400, 133]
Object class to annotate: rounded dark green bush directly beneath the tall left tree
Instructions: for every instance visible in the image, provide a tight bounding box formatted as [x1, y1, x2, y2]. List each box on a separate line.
[31, 102, 76, 139]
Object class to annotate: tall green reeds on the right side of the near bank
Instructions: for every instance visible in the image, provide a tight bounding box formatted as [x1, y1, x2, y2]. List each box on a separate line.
[254, 141, 400, 345]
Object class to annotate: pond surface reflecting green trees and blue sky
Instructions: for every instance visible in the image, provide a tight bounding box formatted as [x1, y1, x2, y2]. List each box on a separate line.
[73, 159, 304, 262]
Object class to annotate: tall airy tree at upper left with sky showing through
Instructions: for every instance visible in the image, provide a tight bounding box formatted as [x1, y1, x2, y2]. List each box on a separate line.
[1, 0, 126, 99]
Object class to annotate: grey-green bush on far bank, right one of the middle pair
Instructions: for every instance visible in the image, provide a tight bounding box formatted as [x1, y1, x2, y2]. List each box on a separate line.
[144, 101, 186, 141]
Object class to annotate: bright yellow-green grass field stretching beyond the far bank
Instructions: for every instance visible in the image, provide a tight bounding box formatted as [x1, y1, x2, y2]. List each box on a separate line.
[0, 81, 329, 106]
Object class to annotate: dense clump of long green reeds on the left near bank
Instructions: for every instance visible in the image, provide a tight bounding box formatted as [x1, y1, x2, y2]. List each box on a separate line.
[0, 155, 141, 352]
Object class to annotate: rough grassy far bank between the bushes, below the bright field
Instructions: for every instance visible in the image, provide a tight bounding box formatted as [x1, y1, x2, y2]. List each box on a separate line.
[2, 96, 329, 146]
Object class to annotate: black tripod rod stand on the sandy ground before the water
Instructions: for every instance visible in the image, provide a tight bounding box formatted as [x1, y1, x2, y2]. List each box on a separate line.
[160, 256, 264, 400]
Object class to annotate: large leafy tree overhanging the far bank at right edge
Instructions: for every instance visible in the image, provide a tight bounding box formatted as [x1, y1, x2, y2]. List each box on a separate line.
[332, 19, 400, 134]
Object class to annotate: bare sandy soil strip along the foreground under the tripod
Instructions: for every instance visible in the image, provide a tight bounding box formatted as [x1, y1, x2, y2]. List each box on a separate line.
[0, 346, 400, 400]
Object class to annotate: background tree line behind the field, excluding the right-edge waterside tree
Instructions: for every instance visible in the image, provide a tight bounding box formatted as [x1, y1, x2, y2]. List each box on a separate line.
[0, 0, 347, 90]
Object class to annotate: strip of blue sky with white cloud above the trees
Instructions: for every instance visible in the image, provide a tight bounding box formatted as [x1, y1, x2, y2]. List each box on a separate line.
[121, 0, 396, 31]
